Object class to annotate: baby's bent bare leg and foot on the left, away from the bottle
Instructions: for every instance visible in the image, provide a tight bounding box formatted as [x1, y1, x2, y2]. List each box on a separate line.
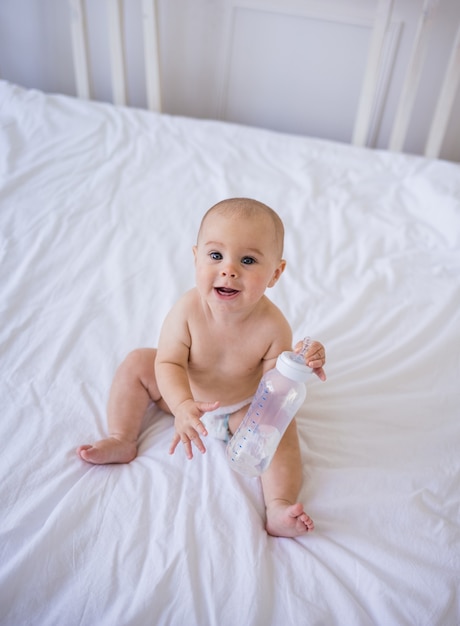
[77, 348, 168, 464]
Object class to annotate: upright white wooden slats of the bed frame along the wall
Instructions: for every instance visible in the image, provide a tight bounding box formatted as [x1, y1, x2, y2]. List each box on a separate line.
[69, 0, 460, 158]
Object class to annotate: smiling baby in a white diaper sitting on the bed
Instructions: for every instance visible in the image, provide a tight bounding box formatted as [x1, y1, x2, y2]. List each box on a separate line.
[77, 198, 326, 537]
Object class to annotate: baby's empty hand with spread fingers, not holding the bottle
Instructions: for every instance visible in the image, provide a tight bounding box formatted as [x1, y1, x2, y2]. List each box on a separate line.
[169, 400, 219, 459]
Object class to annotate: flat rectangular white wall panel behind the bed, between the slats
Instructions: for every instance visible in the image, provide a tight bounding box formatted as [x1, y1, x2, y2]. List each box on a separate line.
[221, 7, 371, 141]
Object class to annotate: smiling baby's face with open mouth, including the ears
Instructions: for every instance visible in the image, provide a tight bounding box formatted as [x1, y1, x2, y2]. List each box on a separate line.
[193, 213, 285, 310]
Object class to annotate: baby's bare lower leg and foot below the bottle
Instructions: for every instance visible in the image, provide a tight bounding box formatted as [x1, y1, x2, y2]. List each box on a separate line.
[262, 420, 314, 537]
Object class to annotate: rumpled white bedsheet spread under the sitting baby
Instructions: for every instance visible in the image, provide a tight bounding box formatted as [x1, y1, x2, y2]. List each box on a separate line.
[0, 82, 460, 626]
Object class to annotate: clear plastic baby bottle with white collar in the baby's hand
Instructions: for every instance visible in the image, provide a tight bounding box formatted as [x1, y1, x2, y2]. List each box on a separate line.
[227, 337, 311, 477]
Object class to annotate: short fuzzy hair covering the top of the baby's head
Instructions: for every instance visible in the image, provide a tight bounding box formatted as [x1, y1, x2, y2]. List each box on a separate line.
[197, 198, 284, 260]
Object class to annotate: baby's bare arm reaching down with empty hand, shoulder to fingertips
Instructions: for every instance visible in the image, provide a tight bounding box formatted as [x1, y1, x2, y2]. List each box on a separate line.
[155, 292, 219, 459]
